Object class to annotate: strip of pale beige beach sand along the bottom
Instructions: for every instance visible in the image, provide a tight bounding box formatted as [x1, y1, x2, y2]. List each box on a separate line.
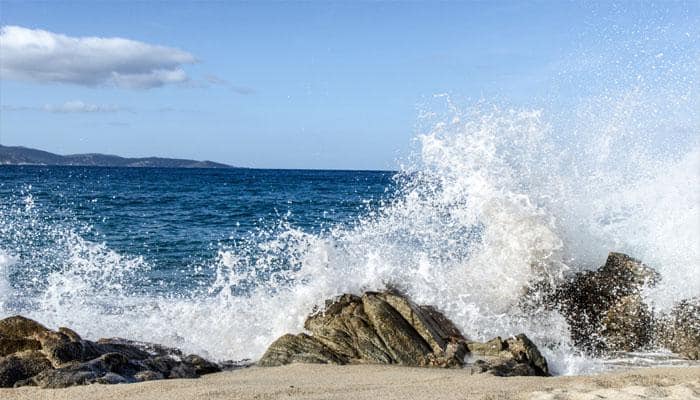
[0, 364, 700, 400]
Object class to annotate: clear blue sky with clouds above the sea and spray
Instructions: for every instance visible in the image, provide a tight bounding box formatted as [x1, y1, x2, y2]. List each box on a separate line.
[0, 0, 700, 169]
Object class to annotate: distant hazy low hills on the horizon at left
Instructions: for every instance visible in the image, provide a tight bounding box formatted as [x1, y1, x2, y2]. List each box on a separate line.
[0, 145, 234, 168]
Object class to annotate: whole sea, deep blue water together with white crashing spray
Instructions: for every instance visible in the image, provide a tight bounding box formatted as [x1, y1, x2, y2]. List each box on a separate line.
[0, 101, 700, 374]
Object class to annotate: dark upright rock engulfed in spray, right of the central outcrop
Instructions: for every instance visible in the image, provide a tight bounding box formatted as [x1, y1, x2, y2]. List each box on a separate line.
[547, 253, 659, 353]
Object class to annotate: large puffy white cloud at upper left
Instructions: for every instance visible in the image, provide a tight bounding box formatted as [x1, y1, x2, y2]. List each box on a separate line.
[0, 26, 197, 89]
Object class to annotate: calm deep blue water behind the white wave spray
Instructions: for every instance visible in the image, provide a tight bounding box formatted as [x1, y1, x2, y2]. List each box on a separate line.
[0, 166, 395, 296]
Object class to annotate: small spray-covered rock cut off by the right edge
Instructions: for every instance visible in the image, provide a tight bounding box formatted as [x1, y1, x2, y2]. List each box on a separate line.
[657, 297, 700, 360]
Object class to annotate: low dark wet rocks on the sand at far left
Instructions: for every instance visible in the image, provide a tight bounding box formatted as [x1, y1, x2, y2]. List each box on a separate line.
[0, 316, 221, 388]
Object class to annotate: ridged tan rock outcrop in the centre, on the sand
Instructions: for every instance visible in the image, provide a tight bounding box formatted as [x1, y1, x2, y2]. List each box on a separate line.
[258, 291, 549, 376]
